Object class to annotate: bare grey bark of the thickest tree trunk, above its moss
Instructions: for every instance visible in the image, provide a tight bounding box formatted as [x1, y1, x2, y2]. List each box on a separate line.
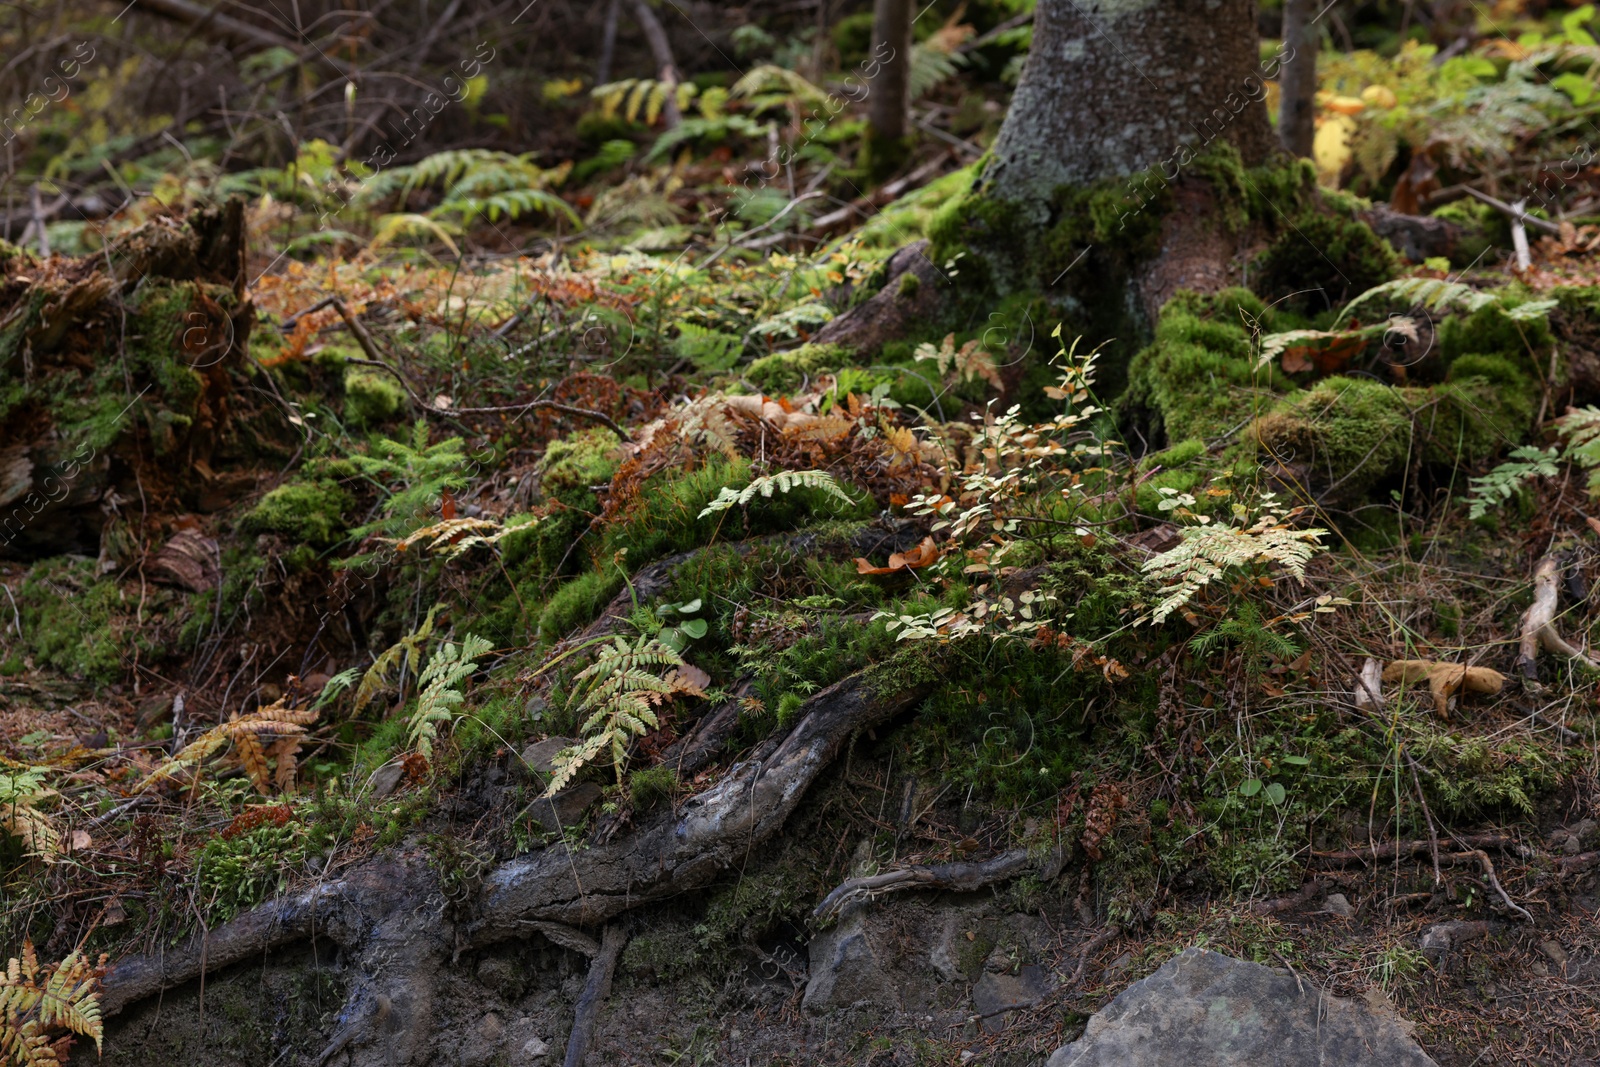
[984, 0, 1272, 212]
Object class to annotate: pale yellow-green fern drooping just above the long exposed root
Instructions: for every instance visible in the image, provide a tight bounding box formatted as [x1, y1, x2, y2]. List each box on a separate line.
[544, 637, 704, 797]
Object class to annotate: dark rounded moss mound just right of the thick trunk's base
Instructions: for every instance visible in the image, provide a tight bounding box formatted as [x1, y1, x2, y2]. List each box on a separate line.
[1251, 213, 1400, 312]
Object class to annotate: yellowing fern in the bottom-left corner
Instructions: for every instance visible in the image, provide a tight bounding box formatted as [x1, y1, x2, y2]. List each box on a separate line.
[0, 941, 106, 1067]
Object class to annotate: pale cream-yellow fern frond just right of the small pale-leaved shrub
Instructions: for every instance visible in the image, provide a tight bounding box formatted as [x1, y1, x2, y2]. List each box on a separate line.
[1144, 494, 1328, 622]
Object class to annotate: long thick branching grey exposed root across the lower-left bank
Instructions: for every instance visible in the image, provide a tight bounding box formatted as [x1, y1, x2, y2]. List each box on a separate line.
[102, 662, 931, 1067]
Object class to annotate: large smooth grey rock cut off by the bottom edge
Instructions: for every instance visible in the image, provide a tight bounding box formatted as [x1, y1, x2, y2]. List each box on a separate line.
[1046, 949, 1434, 1067]
